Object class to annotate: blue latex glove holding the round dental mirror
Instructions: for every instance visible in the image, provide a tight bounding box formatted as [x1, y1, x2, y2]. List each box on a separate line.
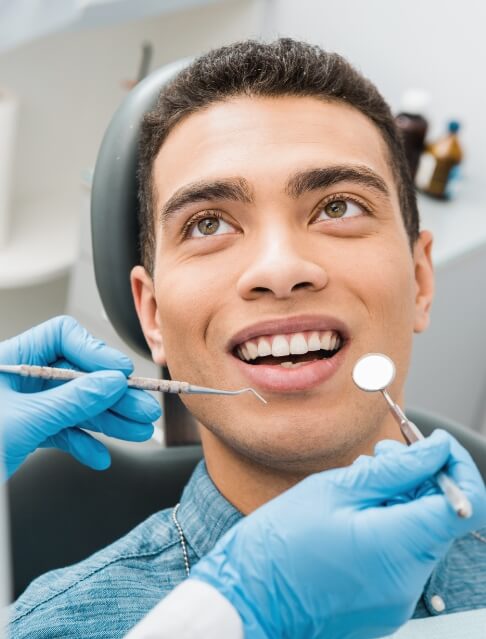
[191, 431, 486, 639]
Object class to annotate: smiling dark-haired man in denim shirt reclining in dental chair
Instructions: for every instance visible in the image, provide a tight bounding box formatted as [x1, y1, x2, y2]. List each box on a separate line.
[12, 40, 486, 637]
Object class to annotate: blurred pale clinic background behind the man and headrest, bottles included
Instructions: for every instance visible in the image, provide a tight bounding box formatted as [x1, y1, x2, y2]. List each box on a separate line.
[0, 0, 486, 434]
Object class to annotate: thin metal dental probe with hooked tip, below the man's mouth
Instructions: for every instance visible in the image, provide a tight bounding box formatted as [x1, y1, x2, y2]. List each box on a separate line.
[0, 364, 267, 404]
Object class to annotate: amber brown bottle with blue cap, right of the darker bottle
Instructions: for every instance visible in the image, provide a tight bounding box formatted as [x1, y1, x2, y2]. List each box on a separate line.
[415, 121, 463, 199]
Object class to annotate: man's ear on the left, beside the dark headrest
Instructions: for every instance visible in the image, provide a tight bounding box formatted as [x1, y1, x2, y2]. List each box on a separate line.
[130, 266, 166, 366]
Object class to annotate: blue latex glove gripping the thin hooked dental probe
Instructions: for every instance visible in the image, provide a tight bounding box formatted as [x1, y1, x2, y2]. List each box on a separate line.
[0, 316, 160, 476]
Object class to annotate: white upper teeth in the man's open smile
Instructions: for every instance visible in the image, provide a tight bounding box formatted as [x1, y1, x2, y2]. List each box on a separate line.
[237, 331, 341, 361]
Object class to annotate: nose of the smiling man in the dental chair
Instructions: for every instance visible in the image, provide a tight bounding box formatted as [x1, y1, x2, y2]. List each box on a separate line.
[237, 232, 328, 300]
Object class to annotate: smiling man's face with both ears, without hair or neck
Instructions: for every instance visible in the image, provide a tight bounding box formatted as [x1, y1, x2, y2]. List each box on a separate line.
[132, 97, 432, 471]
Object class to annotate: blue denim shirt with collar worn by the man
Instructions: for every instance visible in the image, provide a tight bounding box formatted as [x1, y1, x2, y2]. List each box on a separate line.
[10, 461, 486, 639]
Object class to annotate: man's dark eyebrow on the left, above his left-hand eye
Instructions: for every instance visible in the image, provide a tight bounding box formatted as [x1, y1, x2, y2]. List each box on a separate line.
[159, 178, 253, 225]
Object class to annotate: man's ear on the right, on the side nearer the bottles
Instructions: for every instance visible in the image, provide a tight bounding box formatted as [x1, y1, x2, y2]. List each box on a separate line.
[413, 231, 434, 333]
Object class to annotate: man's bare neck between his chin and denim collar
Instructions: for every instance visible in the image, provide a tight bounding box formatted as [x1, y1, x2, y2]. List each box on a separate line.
[200, 400, 405, 515]
